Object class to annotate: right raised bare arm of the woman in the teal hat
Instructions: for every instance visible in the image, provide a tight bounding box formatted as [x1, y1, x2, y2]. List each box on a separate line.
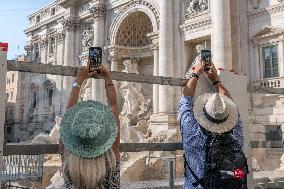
[96, 66, 120, 160]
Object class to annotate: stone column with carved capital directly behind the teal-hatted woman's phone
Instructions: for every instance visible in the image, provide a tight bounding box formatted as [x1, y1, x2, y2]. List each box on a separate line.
[89, 1, 107, 103]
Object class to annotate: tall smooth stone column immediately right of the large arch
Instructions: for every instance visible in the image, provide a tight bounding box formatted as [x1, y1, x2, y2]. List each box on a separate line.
[159, 0, 174, 114]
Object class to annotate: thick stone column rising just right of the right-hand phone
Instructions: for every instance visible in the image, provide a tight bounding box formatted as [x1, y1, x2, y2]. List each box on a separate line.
[211, 0, 233, 69]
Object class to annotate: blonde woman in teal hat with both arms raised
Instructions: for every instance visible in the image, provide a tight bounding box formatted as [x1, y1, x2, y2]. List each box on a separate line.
[57, 66, 120, 189]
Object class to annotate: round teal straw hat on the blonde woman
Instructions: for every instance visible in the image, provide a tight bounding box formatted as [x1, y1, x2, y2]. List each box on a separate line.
[60, 100, 117, 158]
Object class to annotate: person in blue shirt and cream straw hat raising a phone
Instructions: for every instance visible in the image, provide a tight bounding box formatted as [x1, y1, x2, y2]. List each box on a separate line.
[179, 60, 246, 189]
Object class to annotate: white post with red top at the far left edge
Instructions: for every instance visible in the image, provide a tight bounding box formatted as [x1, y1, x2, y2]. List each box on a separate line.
[0, 42, 8, 189]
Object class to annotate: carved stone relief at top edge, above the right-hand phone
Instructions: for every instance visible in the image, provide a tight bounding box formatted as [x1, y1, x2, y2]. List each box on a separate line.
[184, 0, 209, 20]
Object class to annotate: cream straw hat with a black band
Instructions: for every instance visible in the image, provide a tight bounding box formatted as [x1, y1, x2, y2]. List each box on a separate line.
[193, 93, 239, 134]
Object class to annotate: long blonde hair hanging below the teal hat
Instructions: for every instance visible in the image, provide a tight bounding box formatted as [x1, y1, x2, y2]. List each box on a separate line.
[63, 149, 116, 189]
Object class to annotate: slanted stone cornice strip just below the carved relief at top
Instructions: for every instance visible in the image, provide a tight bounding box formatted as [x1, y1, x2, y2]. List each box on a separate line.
[180, 18, 212, 33]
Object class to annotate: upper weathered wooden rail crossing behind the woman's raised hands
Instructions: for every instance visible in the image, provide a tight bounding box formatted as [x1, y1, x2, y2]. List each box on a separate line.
[7, 61, 187, 86]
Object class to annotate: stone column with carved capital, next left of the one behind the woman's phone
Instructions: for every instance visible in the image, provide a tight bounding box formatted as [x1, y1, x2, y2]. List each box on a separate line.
[62, 17, 78, 110]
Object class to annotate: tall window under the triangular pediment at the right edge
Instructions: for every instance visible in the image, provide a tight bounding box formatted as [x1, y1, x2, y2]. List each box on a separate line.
[262, 45, 279, 78]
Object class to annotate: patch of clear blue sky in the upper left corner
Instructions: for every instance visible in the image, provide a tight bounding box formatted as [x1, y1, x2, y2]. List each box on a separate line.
[0, 0, 52, 59]
